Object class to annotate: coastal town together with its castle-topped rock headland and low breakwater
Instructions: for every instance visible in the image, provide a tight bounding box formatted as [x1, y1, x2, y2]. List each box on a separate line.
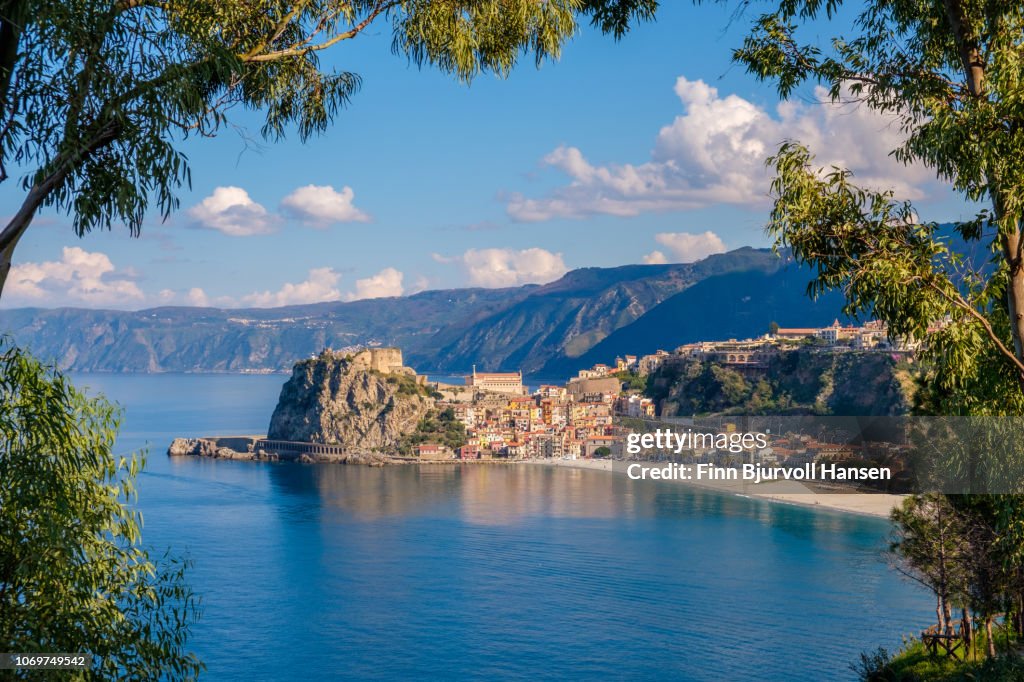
[168, 321, 915, 489]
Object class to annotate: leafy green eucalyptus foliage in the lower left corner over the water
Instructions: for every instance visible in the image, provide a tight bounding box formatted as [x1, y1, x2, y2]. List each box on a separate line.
[0, 340, 202, 680]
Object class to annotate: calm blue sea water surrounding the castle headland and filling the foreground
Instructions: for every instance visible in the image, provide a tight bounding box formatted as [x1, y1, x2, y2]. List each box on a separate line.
[76, 375, 932, 681]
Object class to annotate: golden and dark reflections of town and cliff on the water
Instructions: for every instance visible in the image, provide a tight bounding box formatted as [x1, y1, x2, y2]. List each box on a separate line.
[268, 464, 887, 542]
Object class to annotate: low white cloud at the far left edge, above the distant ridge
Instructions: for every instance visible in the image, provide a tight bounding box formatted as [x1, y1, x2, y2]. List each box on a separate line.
[4, 247, 145, 307]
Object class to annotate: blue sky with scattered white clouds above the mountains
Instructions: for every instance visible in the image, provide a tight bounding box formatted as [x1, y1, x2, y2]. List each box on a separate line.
[0, 2, 971, 308]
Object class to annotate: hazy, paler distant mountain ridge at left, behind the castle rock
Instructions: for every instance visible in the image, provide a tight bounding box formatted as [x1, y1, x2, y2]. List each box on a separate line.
[0, 286, 536, 372]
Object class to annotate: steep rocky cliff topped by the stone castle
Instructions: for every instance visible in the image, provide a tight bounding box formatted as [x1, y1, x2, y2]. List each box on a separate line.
[267, 348, 434, 452]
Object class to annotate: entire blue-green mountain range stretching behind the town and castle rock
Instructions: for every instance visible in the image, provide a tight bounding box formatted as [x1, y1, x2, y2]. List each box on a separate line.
[0, 248, 842, 378]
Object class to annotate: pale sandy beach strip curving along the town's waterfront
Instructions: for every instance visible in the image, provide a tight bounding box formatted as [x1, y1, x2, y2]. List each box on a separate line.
[530, 460, 906, 518]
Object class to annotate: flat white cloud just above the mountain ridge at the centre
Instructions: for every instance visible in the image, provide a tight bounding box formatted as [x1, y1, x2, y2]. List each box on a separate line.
[433, 248, 568, 287]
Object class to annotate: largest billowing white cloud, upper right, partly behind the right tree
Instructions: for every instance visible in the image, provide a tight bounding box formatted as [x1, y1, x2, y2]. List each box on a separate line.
[507, 77, 934, 222]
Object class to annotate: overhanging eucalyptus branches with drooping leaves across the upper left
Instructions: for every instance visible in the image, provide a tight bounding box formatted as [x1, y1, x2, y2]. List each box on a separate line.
[0, 0, 656, 290]
